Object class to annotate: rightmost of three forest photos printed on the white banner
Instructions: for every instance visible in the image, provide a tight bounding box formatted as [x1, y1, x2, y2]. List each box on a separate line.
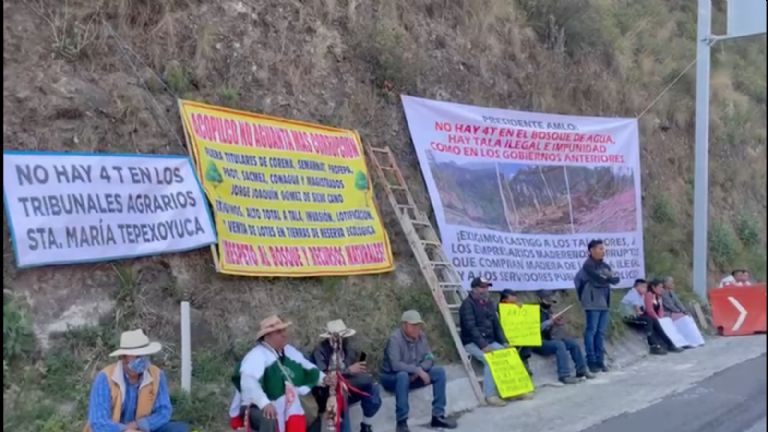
[566, 166, 637, 233]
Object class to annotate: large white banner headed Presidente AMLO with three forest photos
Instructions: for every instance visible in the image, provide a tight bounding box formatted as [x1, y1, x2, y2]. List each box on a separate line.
[403, 96, 645, 290]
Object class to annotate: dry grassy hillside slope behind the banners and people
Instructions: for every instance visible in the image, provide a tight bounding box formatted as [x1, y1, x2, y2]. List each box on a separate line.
[3, 0, 766, 432]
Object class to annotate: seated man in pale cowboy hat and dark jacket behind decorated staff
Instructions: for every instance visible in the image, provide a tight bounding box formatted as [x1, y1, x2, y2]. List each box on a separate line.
[312, 319, 381, 432]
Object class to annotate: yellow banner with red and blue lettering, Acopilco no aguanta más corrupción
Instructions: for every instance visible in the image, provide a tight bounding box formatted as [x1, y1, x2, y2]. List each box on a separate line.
[179, 100, 394, 277]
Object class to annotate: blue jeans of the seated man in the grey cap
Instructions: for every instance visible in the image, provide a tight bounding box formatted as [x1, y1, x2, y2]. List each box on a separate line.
[379, 366, 446, 422]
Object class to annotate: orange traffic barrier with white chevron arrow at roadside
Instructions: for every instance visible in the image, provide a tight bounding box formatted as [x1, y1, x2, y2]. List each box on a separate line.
[709, 283, 768, 336]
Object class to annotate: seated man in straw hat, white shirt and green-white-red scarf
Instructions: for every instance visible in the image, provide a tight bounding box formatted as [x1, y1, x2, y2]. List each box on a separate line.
[230, 315, 333, 432]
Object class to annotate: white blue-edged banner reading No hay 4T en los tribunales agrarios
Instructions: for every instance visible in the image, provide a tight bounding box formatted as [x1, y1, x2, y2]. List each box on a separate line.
[3, 151, 216, 267]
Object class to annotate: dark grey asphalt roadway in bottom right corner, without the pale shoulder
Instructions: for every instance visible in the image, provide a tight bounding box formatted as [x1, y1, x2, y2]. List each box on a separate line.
[584, 354, 766, 432]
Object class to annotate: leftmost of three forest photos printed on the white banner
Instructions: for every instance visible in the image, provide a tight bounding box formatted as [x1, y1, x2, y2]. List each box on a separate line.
[427, 151, 508, 231]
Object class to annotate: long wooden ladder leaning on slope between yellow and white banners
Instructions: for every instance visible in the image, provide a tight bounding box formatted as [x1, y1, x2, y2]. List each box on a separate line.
[365, 146, 485, 405]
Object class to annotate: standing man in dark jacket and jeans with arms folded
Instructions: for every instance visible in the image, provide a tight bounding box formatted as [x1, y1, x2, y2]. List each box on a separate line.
[574, 240, 619, 372]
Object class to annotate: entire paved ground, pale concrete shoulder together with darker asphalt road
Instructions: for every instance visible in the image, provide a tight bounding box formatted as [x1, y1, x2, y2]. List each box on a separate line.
[438, 335, 768, 432]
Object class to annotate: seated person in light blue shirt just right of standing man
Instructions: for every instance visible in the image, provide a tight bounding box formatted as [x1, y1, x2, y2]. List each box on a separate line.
[621, 279, 675, 355]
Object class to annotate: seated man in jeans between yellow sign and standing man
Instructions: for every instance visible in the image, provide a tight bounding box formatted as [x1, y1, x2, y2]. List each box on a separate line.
[533, 290, 595, 384]
